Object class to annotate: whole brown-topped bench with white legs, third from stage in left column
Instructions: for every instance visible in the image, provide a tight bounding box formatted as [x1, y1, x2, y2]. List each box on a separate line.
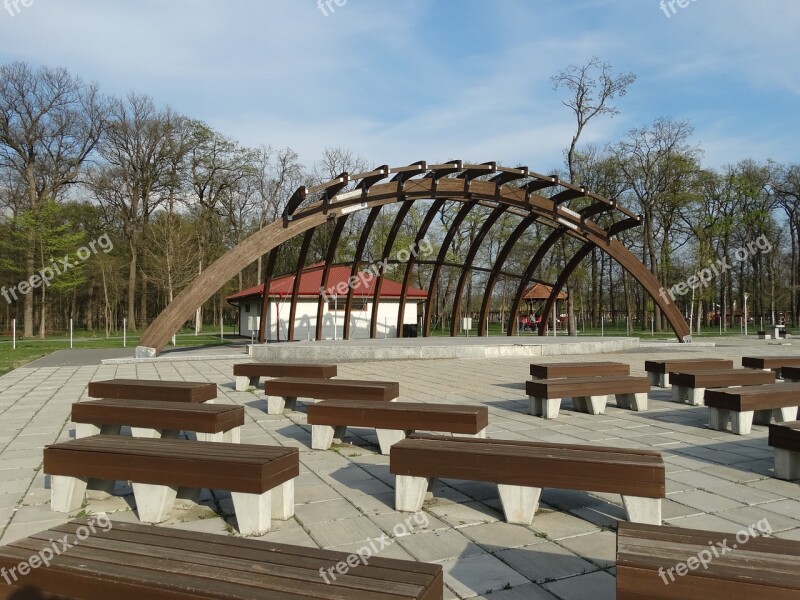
[43, 435, 300, 535]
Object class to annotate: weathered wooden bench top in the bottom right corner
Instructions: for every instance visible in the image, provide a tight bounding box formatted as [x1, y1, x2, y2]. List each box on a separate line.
[616, 521, 800, 600]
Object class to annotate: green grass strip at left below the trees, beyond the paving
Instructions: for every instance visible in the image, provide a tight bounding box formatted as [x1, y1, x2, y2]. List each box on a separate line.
[0, 326, 236, 375]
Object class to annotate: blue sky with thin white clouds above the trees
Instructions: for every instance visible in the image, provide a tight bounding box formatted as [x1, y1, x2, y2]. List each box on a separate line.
[0, 0, 800, 173]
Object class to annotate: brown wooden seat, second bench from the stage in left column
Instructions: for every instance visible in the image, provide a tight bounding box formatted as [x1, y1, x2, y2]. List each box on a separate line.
[72, 398, 244, 433]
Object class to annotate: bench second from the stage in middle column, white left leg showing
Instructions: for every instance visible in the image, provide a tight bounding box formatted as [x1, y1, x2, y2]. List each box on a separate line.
[264, 377, 400, 415]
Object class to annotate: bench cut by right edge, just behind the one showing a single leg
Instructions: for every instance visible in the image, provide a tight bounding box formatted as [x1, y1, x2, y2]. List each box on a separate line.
[705, 383, 800, 435]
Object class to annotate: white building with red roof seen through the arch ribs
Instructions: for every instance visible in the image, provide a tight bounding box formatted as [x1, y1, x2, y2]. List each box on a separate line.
[226, 263, 428, 340]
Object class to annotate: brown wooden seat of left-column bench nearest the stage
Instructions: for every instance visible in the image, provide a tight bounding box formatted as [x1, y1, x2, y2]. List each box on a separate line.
[89, 379, 217, 404]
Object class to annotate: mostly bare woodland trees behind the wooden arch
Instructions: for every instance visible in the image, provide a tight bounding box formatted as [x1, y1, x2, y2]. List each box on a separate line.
[0, 63, 800, 337]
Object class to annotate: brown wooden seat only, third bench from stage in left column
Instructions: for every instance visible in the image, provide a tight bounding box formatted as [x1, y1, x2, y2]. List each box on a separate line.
[43, 436, 300, 493]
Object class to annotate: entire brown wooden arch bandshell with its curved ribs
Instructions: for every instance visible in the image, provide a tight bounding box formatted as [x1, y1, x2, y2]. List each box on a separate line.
[137, 161, 691, 356]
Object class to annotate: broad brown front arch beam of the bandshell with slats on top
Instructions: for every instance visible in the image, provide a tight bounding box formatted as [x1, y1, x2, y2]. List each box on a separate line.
[137, 163, 691, 356]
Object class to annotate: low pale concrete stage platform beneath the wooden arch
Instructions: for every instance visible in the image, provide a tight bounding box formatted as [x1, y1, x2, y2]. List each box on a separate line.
[248, 336, 640, 362]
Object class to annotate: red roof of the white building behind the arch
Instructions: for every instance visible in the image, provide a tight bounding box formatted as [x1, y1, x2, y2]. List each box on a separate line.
[226, 263, 428, 303]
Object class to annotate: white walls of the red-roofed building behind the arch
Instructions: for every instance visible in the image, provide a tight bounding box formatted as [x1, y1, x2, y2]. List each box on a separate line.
[234, 298, 420, 340]
